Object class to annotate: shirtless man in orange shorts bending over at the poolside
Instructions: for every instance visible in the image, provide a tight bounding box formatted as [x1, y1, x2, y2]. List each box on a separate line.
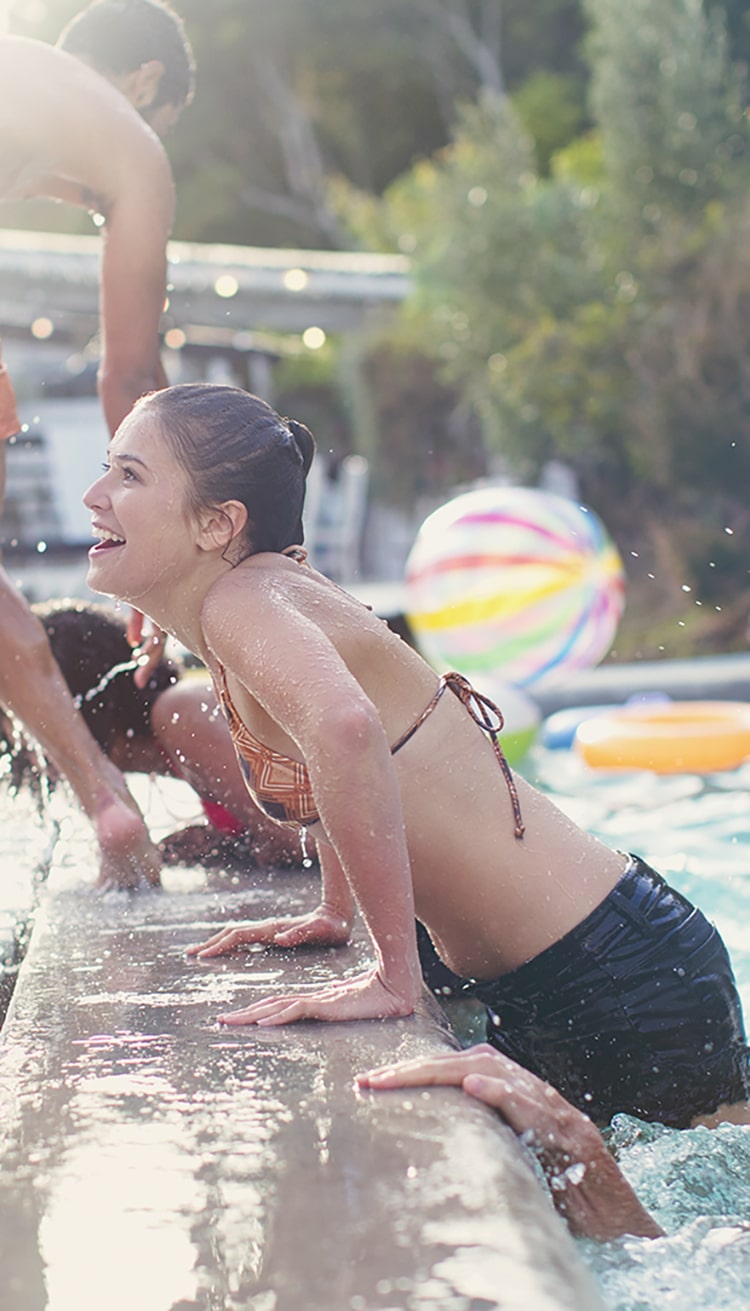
[0, 0, 193, 886]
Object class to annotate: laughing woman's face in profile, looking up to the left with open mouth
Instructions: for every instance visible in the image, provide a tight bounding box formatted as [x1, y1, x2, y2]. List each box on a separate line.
[84, 406, 197, 614]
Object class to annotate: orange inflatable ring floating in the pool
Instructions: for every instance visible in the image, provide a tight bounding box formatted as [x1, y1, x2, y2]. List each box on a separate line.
[573, 701, 750, 773]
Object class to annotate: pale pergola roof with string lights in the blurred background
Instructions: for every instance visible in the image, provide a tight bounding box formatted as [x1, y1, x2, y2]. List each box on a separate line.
[0, 229, 409, 351]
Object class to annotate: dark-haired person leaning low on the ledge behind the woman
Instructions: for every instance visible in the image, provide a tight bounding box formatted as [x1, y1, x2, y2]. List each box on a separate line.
[0, 599, 303, 868]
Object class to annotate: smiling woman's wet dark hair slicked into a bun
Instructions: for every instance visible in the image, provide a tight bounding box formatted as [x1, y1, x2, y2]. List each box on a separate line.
[136, 383, 315, 564]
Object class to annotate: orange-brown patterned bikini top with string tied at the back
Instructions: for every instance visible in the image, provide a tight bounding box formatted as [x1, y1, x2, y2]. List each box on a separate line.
[213, 665, 523, 838]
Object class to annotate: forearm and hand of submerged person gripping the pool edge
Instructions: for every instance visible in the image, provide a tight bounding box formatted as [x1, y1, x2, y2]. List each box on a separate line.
[357, 1044, 663, 1240]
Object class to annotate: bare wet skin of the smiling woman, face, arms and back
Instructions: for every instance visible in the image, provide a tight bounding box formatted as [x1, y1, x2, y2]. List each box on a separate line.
[85, 404, 624, 1025]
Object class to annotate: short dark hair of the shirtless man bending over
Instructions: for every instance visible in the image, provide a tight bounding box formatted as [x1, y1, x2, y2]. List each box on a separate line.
[58, 0, 195, 111]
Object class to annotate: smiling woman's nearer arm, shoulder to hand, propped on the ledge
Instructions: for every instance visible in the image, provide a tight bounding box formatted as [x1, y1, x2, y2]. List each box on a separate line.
[192, 576, 422, 1024]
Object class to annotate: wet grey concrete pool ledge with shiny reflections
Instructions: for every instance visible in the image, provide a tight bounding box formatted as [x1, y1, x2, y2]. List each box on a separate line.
[0, 802, 601, 1311]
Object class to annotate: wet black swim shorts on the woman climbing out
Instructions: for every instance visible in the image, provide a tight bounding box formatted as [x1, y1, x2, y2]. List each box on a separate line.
[471, 856, 750, 1129]
